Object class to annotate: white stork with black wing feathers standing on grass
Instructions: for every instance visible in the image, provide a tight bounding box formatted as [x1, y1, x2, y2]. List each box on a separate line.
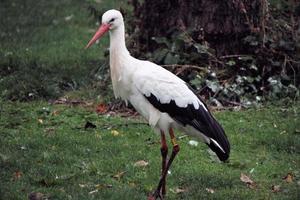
[86, 10, 230, 200]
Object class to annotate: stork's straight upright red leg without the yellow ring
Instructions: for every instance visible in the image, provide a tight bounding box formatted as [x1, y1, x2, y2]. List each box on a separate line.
[160, 131, 168, 196]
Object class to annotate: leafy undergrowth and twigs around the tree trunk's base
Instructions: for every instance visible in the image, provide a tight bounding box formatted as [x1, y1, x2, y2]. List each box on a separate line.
[127, 1, 300, 106]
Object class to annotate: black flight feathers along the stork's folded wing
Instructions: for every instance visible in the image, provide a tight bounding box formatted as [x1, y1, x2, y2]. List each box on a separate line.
[144, 94, 230, 161]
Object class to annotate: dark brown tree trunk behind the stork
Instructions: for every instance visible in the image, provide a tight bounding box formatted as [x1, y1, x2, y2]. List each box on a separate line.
[132, 0, 266, 56]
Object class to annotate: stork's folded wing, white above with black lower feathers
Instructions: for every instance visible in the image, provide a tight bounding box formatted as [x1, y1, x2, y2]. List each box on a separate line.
[134, 61, 230, 160]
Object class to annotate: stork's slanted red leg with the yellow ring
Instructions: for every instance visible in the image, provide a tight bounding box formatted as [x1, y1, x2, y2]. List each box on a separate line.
[148, 128, 179, 200]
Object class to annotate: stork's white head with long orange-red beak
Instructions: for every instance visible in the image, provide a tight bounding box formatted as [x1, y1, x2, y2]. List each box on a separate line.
[85, 9, 124, 48]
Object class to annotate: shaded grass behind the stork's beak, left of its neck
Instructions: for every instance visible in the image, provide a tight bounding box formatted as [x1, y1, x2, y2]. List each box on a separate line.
[0, 0, 128, 100]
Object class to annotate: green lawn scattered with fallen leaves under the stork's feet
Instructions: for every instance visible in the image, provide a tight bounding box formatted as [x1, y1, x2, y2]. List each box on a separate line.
[0, 101, 300, 200]
